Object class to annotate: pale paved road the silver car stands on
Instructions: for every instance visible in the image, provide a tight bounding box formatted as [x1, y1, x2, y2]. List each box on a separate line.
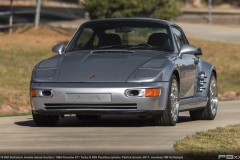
[0, 101, 240, 155]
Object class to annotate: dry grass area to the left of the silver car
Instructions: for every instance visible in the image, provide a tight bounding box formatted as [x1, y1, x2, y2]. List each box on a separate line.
[0, 27, 73, 113]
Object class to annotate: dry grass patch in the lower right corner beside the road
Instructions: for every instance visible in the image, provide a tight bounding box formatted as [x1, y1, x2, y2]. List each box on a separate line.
[173, 124, 240, 160]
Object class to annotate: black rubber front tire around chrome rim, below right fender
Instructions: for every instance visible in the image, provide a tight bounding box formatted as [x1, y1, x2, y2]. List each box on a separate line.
[153, 75, 179, 126]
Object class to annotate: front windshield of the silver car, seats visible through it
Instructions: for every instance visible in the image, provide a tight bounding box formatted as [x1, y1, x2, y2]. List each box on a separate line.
[66, 20, 173, 51]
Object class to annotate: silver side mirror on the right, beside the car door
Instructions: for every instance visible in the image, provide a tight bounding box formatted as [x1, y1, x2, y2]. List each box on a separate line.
[179, 44, 202, 57]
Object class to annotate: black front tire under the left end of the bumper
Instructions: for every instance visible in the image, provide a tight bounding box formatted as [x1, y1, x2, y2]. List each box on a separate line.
[32, 113, 59, 126]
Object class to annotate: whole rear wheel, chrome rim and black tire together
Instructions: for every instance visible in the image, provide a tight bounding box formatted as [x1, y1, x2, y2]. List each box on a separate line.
[189, 73, 218, 120]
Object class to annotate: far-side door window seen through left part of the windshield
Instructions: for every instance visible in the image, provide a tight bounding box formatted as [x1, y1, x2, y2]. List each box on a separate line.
[73, 28, 93, 50]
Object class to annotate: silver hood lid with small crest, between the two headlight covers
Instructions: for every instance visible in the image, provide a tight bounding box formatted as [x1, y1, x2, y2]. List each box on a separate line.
[58, 51, 166, 82]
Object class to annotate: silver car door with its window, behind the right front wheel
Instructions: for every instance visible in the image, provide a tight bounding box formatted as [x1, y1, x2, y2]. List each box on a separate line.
[172, 27, 196, 98]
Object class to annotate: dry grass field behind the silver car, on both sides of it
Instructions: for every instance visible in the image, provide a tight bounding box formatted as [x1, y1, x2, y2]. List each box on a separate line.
[0, 27, 240, 110]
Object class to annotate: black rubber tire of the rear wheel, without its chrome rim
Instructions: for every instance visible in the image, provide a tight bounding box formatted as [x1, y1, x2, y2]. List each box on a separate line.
[189, 73, 218, 120]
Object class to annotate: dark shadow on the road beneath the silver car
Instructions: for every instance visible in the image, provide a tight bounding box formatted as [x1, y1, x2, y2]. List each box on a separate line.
[15, 115, 192, 127]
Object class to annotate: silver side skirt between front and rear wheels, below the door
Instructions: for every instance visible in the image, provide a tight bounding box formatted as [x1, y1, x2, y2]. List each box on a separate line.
[179, 97, 208, 112]
